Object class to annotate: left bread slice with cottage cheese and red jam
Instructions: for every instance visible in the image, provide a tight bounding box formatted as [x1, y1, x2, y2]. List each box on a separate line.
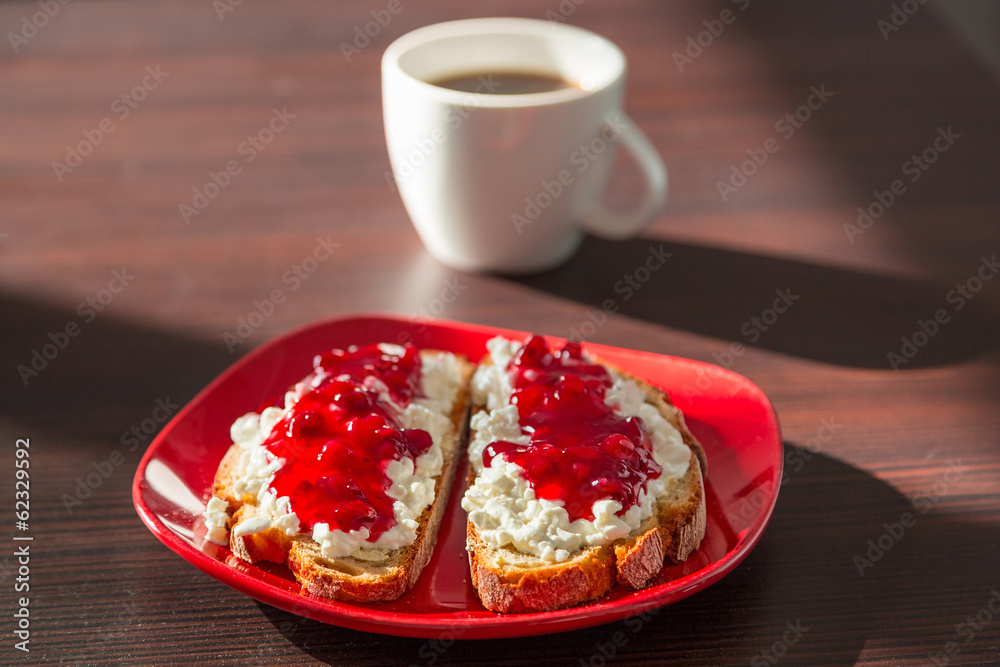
[204, 344, 473, 602]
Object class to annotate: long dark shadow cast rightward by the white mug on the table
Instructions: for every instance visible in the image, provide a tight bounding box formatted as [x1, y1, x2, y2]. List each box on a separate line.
[513, 237, 1000, 370]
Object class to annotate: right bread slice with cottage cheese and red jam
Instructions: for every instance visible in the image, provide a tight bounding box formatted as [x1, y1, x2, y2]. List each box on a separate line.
[462, 336, 706, 612]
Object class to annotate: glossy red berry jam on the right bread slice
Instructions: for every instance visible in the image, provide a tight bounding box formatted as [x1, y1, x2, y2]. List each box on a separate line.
[483, 336, 660, 521]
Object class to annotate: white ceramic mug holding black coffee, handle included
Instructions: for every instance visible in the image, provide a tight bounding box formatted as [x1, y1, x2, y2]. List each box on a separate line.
[382, 18, 667, 273]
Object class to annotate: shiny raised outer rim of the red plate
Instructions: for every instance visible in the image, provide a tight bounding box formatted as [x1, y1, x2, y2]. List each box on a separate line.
[132, 312, 784, 639]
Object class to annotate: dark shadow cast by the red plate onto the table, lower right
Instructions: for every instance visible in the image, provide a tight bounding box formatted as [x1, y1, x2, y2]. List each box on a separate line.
[259, 443, 1000, 665]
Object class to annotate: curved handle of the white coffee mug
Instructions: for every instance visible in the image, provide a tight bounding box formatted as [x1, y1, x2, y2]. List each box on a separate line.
[583, 116, 667, 240]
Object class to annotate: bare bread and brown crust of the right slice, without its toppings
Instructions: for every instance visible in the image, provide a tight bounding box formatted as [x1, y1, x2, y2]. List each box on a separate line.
[467, 350, 707, 613]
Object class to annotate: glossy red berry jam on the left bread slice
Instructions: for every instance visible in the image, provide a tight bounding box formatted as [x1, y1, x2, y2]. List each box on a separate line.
[264, 345, 431, 541]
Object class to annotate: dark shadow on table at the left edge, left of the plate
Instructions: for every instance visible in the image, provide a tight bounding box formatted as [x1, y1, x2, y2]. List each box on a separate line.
[0, 292, 233, 436]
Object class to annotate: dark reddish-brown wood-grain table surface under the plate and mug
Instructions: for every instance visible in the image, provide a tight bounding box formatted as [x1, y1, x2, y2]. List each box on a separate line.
[0, 0, 1000, 666]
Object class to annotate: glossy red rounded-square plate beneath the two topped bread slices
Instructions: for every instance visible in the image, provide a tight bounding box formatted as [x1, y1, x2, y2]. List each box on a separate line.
[132, 315, 783, 639]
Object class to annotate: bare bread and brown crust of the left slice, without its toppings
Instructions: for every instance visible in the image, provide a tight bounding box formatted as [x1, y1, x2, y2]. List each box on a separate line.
[207, 350, 474, 602]
